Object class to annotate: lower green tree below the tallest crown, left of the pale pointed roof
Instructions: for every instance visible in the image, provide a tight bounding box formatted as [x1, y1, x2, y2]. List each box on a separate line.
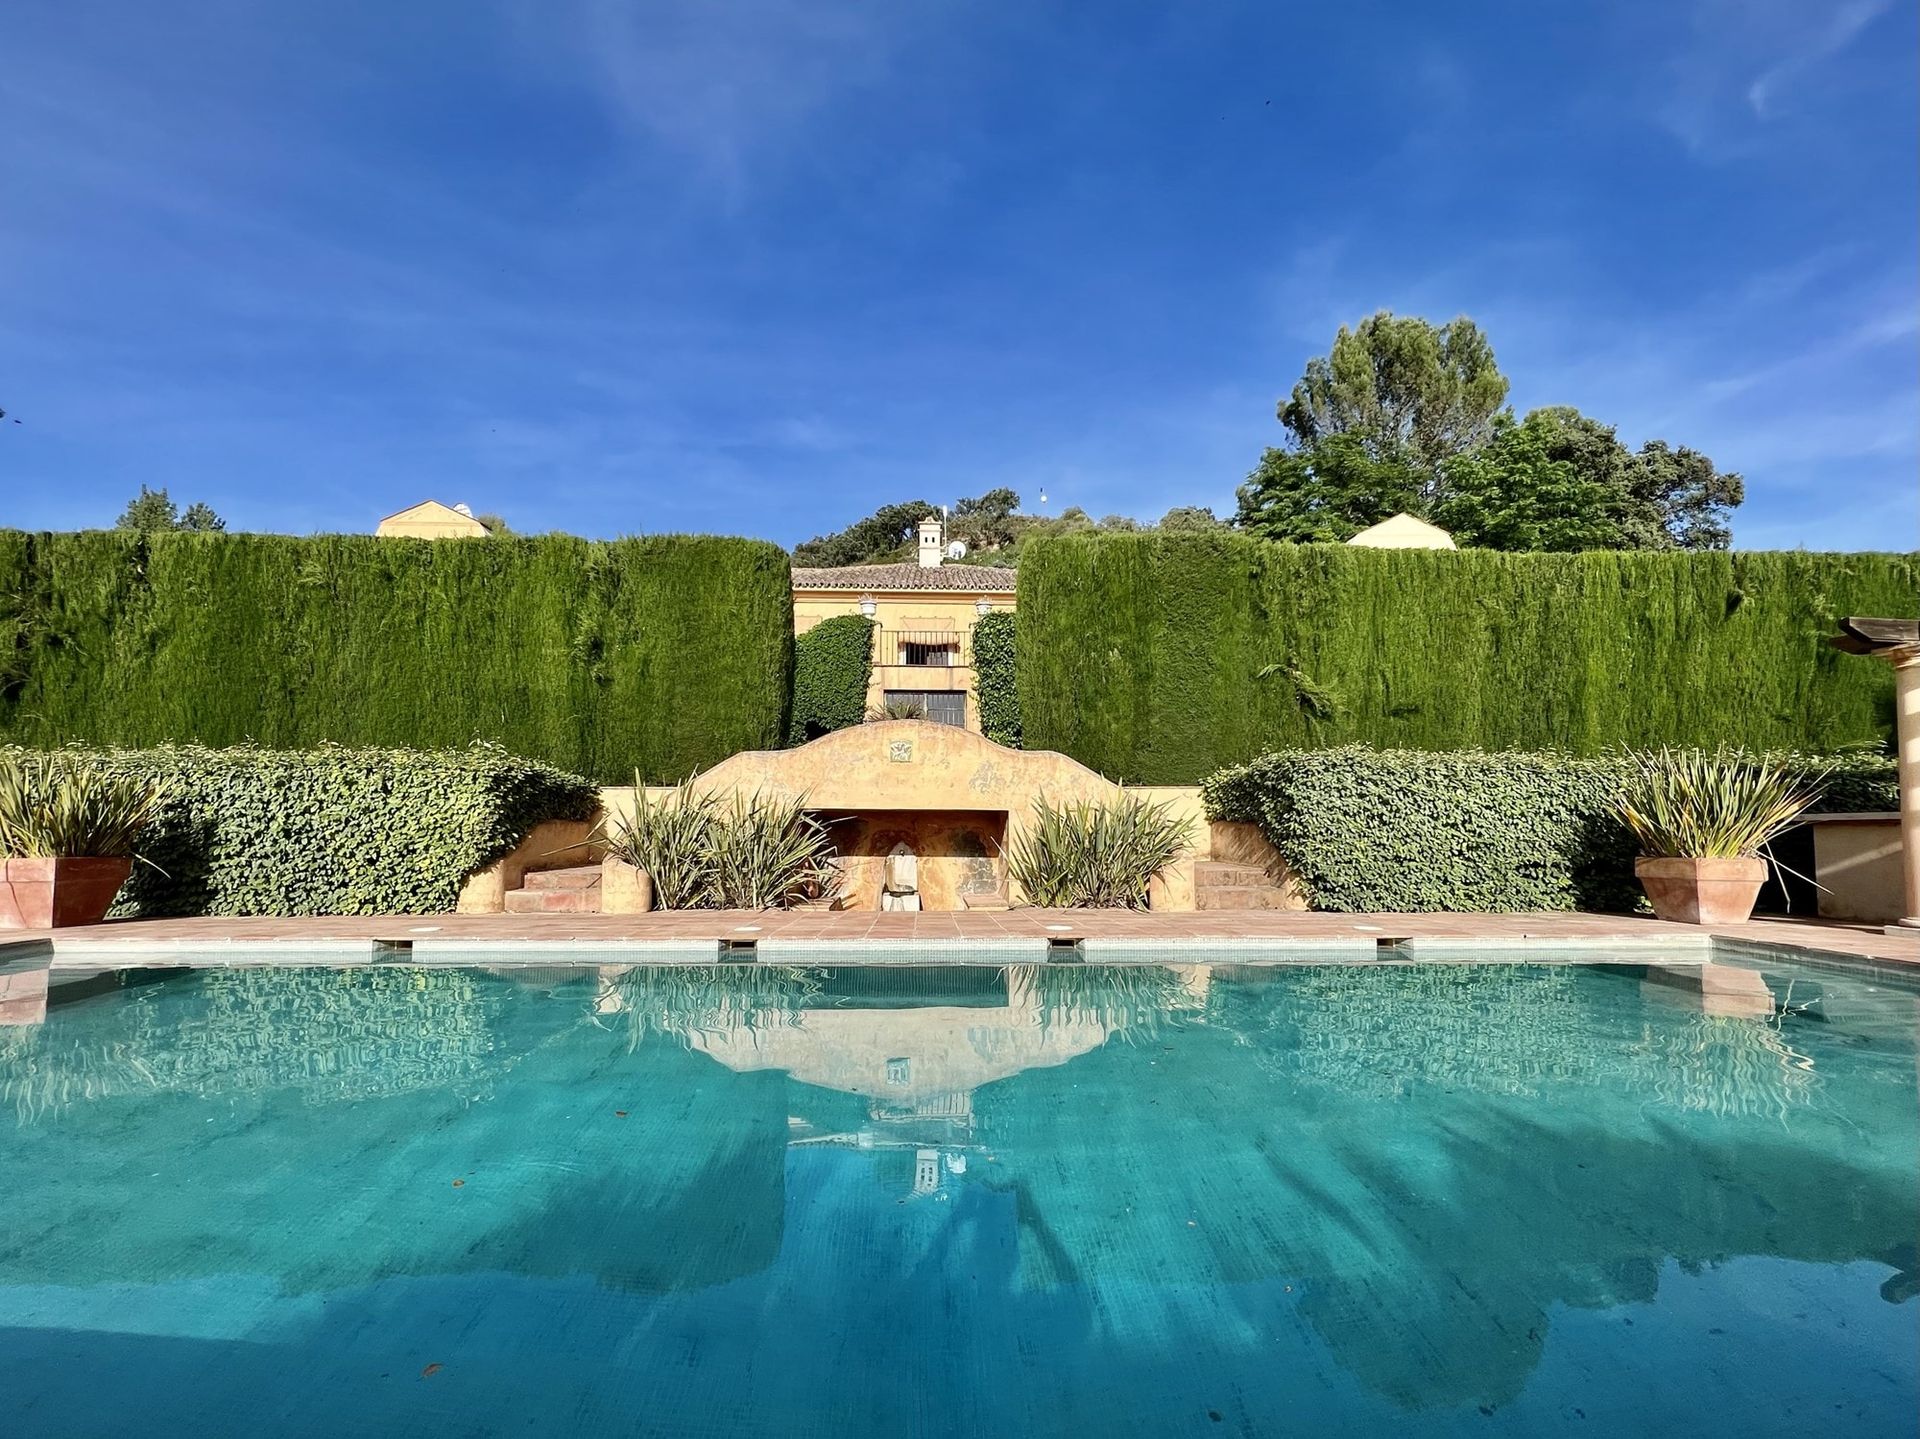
[1235, 434, 1430, 544]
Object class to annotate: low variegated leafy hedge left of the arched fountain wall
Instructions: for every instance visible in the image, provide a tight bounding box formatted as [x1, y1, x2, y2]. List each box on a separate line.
[11, 745, 599, 916]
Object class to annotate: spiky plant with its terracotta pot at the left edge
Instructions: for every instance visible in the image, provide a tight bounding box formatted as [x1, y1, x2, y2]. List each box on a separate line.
[0, 753, 161, 930]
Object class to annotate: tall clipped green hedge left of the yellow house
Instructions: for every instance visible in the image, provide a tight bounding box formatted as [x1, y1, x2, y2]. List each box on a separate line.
[0, 530, 793, 782]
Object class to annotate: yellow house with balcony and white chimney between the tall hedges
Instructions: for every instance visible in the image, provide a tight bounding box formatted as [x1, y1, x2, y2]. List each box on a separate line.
[793, 519, 1014, 732]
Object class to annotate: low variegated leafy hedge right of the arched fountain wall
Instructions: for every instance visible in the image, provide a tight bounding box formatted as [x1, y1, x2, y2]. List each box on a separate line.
[1202, 745, 1899, 913]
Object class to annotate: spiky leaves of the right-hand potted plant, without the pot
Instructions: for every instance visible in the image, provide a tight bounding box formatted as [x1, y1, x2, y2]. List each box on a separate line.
[1617, 749, 1828, 859]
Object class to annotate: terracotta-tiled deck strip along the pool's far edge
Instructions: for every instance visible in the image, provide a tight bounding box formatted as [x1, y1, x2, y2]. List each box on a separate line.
[0, 909, 1920, 966]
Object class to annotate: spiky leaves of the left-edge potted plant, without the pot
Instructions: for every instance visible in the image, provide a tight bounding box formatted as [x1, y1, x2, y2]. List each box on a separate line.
[0, 753, 165, 859]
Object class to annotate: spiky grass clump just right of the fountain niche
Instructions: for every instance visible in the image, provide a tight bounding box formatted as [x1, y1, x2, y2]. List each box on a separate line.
[1006, 795, 1188, 909]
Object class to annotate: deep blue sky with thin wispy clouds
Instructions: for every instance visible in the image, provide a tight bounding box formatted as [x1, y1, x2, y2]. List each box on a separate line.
[0, 0, 1920, 549]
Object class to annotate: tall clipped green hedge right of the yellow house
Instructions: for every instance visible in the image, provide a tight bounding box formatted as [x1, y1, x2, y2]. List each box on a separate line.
[1018, 534, 1920, 784]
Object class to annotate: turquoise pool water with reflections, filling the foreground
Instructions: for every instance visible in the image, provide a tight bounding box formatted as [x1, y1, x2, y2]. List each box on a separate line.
[0, 963, 1920, 1439]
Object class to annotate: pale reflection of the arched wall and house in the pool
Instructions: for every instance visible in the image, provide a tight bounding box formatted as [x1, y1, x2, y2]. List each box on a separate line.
[595, 964, 1210, 1195]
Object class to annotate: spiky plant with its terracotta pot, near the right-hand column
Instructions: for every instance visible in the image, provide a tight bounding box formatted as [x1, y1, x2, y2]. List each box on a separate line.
[1617, 749, 1824, 924]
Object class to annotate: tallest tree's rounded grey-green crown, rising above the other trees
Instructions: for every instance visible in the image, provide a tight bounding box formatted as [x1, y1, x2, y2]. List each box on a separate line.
[1279, 309, 1507, 471]
